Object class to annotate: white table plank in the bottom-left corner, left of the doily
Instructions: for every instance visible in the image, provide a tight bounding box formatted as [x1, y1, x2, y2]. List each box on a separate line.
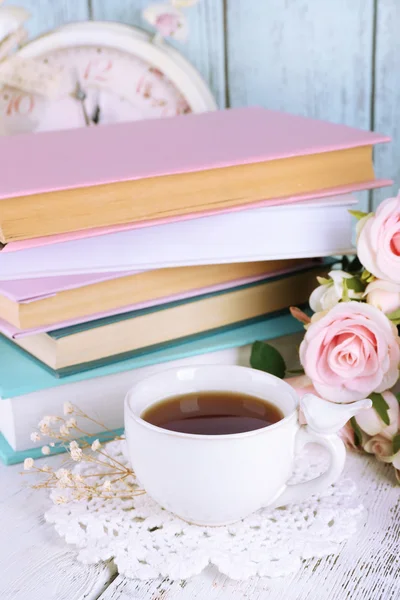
[0, 456, 115, 600]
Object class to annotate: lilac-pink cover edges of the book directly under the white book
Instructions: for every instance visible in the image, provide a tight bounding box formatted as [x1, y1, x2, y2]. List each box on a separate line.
[0, 259, 320, 339]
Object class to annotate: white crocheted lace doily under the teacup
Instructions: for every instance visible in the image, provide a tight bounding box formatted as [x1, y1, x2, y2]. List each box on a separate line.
[45, 441, 363, 579]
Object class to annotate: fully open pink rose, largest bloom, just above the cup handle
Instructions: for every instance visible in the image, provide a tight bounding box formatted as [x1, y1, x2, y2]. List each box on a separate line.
[300, 302, 400, 403]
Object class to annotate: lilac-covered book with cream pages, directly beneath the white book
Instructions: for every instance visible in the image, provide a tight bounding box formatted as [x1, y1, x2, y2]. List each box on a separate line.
[0, 259, 304, 329]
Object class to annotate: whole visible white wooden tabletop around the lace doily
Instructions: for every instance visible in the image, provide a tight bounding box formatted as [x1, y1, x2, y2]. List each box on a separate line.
[0, 436, 400, 600]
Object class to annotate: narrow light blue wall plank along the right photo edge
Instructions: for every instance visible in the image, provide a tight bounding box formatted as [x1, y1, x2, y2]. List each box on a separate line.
[373, 0, 400, 208]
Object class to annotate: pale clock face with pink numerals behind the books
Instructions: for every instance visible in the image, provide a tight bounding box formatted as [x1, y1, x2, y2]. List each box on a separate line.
[0, 45, 191, 135]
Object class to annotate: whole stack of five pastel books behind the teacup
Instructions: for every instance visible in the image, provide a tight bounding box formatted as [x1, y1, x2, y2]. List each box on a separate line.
[0, 108, 391, 463]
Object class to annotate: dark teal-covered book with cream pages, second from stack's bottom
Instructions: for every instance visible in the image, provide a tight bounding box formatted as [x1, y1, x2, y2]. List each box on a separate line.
[14, 265, 327, 373]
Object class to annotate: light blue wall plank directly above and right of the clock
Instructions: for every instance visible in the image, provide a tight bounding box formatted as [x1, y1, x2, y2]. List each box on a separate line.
[92, 0, 225, 108]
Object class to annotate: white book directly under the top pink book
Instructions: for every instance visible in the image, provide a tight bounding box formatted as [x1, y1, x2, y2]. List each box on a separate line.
[0, 195, 357, 280]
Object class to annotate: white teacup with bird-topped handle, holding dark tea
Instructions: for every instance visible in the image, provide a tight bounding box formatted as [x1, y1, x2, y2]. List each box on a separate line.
[125, 365, 370, 525]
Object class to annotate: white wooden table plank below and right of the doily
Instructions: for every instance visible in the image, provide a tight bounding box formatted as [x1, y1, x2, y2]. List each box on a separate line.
[94, 454, 400, 600]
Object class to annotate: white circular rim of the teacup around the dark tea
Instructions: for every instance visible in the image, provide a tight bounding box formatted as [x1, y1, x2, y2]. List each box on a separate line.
[124, 364, 299, 442]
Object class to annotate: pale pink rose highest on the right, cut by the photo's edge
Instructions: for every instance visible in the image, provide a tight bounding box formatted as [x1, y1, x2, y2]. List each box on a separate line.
[357, 196, 400, 283]
